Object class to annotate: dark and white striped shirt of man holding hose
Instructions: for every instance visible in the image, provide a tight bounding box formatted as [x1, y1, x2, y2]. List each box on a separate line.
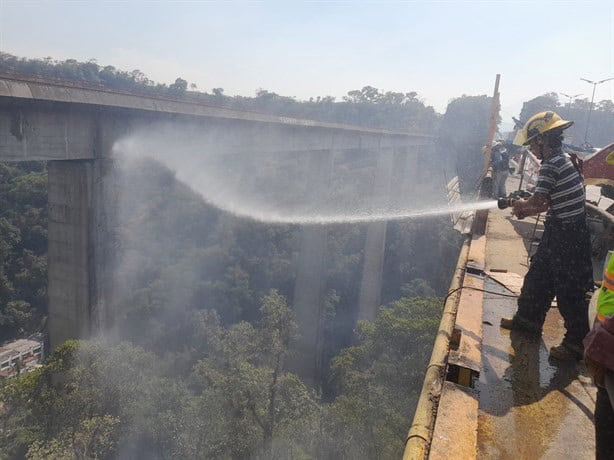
[535, 152, 586, 222]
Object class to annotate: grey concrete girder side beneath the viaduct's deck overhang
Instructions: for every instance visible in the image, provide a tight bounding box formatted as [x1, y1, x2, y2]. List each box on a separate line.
[0, 109, 428, 161]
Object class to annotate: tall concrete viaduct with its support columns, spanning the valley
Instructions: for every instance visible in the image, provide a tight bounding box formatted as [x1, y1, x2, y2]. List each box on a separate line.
[0, 77, 433, 382]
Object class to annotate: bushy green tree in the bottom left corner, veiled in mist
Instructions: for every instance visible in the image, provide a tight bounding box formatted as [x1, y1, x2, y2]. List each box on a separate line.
[0, 341, 190, 458]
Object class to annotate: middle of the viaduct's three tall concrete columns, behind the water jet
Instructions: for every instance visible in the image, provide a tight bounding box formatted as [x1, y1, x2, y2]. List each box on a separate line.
[291, 150, 333, 388]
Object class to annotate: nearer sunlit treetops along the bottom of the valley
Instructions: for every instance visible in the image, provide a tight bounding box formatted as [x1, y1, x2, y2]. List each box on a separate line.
[0, 291, 441, 459]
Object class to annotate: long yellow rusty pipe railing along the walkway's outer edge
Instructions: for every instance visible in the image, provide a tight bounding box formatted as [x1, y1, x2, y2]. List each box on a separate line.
[403, 235, 472, 460]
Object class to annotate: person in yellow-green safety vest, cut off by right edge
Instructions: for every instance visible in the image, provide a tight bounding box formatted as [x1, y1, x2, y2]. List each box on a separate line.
[584, 251, 614, 460]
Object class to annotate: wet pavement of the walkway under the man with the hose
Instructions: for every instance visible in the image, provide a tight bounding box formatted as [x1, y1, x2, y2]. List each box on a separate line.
[476, 210, 596, 459]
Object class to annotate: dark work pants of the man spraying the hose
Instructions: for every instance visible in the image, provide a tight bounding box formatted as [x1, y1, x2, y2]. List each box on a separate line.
[517, 219, 593, 346]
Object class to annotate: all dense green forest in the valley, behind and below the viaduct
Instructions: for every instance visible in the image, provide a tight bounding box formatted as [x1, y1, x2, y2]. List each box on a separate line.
[0, 54, 512, 459]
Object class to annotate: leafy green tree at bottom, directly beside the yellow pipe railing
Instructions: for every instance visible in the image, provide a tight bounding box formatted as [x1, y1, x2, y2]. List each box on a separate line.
[326, 298, 443, 458]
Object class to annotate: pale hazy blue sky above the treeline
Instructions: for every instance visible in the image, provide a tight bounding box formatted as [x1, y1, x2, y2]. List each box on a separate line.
[0, 0, 614, 128]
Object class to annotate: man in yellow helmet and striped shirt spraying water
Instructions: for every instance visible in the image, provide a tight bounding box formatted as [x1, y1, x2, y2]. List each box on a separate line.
[501, 111, 594, 360]
